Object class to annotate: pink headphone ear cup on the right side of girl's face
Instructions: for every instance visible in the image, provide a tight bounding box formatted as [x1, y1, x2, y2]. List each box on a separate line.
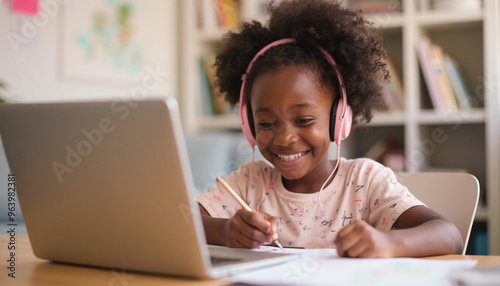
[330, 96, 352, 145]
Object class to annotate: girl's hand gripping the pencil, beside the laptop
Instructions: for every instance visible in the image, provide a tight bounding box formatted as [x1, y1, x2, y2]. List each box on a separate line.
[225, 209, 278, 248]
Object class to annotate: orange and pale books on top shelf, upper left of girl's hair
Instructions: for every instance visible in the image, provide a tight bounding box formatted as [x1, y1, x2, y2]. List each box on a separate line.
[197, 0, 240, 30]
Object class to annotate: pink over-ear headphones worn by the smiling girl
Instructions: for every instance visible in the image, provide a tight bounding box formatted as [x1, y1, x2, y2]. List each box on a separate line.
[240, 38, 352, 147]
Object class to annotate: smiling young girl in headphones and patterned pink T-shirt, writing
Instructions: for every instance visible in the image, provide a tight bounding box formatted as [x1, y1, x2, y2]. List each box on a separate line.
[197, 0, 463, 257]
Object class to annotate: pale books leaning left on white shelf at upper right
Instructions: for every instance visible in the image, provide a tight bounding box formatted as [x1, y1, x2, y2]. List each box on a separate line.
[417, 36, 472, 112]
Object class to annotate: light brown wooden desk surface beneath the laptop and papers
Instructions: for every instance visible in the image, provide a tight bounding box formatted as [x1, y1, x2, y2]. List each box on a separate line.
[0, 235, 500, 286]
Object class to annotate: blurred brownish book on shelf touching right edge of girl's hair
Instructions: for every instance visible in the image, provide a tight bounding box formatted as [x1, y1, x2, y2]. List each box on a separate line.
[382, 58, 404, 110]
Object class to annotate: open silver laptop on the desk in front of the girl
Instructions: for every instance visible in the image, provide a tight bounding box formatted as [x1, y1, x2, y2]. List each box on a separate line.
[0, 98, 296, 278]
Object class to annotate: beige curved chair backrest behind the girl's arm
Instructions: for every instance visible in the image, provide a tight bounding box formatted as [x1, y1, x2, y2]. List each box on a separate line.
[396, 172, 479, 254]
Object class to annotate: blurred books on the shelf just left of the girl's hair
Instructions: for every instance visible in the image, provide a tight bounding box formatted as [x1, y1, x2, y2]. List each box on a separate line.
[200, 55, 231, 115]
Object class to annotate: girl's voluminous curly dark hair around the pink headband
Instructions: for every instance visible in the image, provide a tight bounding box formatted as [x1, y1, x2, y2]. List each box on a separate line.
[215, 0, 389, 123]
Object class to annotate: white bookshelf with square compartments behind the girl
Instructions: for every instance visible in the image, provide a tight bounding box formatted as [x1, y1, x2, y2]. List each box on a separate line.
[180, 0, 500, 255]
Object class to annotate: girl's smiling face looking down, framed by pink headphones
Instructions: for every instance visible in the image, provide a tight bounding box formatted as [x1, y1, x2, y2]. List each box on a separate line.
[250, 66, 334, 192]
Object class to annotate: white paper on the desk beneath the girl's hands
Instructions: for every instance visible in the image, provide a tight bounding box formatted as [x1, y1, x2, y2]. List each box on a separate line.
[229, 247, 477, 286]
